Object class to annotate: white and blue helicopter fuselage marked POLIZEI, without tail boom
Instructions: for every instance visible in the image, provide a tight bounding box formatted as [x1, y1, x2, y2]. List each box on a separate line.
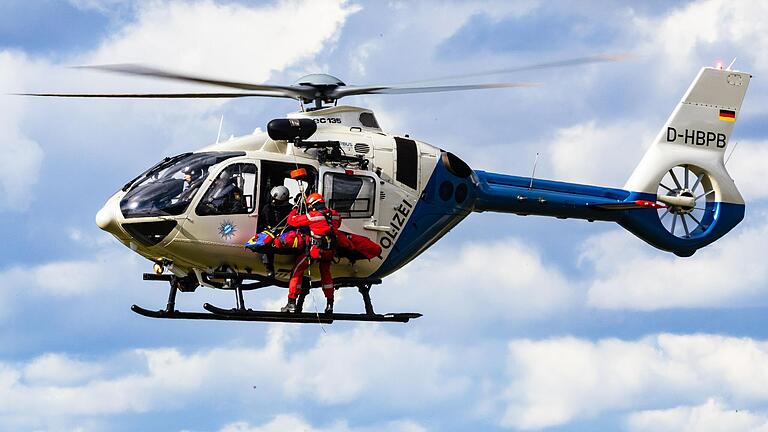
[96, 106, 476, 281]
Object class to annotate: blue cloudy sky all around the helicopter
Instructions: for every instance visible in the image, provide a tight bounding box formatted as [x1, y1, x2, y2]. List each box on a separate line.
[0, 0, 768, 432]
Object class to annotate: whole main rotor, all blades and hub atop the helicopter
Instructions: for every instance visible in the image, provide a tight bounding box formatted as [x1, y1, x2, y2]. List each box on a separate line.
[19, 55, 626, 108]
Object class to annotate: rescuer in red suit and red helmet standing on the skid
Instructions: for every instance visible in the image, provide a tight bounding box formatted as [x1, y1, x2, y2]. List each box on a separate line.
[280, 193, 341, 314]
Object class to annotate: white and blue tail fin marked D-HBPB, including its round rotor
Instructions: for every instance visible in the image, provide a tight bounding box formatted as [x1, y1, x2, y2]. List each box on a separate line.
[620, 68, 752, 256]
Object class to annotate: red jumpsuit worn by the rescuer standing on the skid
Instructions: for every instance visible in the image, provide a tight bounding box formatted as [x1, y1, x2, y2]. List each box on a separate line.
[288, 209, 341, 300]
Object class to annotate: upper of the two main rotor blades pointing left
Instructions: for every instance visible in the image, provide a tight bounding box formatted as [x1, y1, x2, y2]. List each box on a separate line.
[77, 64, 308, 99]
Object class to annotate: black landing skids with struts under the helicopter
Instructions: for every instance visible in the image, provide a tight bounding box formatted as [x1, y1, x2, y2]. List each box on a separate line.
[131, 275, 421, 324]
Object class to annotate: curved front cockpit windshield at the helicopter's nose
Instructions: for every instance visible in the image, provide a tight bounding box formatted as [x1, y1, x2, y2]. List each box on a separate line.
[120, 152, 245, 218]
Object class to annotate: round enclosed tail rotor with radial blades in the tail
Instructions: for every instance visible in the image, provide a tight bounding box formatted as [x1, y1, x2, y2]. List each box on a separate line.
[657, 165, 715, 239]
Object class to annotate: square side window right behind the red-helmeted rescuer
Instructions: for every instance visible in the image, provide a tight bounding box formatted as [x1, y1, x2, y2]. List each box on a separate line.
[323, 173, 376, 218]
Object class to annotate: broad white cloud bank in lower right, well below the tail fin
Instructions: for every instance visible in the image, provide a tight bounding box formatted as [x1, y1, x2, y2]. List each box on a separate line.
[502, 334, 768, 429]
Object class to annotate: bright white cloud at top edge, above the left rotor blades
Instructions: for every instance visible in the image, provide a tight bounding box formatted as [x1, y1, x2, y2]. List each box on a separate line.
[86, 0, 359, 83]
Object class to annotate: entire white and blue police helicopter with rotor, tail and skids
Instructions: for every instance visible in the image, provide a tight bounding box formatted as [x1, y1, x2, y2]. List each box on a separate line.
[26, 56, 751, 323]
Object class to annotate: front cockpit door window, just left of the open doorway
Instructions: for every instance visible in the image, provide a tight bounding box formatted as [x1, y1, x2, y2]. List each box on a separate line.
[195, 163, 257, 216]
